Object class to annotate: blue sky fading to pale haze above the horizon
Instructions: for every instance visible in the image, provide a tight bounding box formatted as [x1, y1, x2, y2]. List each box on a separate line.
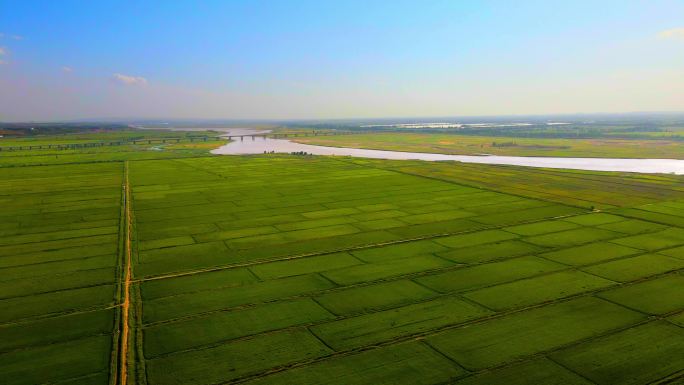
[0, 0, 684, 121]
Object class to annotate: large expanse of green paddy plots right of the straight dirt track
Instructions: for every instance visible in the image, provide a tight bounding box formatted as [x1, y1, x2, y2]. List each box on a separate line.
[123, 156, 684, 384]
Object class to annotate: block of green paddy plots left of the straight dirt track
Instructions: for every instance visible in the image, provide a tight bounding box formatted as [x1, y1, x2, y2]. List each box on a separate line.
[0, 163, 123, 384]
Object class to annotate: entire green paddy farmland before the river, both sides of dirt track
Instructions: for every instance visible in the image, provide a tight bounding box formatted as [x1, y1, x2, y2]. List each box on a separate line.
[0, 140, 684, 385]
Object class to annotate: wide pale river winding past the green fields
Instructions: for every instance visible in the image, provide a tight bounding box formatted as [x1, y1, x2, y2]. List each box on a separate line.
[212, 130, 684, 174]
